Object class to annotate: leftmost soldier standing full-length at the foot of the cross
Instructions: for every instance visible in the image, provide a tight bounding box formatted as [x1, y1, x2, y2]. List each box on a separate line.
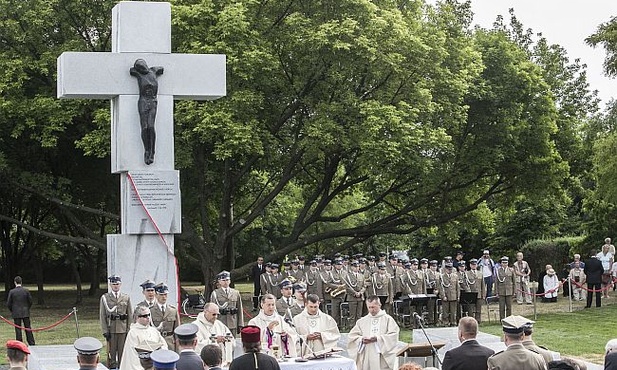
[99, 275, 133, 369]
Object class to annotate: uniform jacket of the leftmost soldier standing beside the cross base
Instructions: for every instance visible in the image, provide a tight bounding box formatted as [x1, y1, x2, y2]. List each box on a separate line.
[99, 292, 133, 334]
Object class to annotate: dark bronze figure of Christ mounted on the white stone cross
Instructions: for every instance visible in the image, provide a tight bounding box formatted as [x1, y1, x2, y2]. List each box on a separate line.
[131, 59, 163, 164]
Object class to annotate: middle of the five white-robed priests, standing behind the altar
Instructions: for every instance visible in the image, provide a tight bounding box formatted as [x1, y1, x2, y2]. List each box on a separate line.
[248, 293, 298, 357]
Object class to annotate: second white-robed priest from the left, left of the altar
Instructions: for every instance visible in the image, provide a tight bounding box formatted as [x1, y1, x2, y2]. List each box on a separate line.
[193, 302, 236, 367]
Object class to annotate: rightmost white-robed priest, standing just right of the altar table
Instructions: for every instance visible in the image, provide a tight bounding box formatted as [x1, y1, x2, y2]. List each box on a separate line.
[347, 295, 400, 370]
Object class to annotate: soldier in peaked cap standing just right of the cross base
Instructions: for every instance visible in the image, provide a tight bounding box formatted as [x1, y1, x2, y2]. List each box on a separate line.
[210, 271, 244, 333]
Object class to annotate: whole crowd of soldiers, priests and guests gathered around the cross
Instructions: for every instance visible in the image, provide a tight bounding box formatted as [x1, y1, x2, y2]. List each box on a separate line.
[7, 239, 617, 370]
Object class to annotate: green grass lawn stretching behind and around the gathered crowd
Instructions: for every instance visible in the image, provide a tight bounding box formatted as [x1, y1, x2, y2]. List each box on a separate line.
[0, 282, 617, 364]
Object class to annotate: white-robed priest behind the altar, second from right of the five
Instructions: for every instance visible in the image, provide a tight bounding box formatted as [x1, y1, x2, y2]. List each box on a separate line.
[293, 294, 341, 356]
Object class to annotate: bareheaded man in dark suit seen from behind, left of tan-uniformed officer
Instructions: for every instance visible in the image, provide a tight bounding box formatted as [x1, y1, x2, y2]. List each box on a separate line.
[441, 316, 495, 370]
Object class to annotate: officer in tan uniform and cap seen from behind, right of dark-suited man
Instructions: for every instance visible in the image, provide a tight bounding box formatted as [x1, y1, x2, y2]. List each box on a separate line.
[487, 316, 547, 370]
